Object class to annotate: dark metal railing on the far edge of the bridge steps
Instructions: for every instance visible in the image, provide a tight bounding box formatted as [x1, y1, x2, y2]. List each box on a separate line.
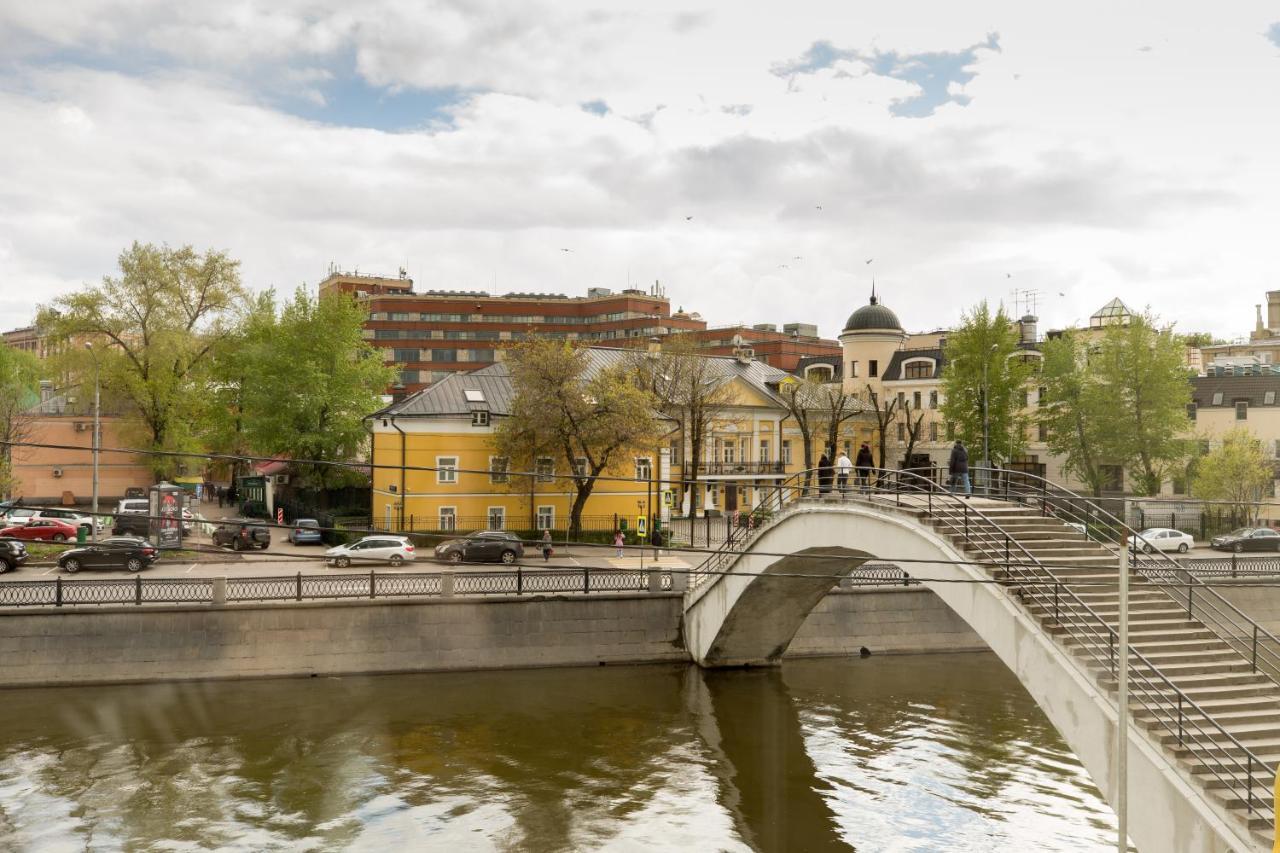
[978, 469, 1280, 685]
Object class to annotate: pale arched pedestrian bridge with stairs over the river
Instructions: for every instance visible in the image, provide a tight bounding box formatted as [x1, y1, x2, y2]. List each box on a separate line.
[684, 487, 1280, 853]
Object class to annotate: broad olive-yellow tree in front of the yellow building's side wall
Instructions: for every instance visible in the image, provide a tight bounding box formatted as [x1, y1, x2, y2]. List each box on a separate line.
[507, 338, 658, 539]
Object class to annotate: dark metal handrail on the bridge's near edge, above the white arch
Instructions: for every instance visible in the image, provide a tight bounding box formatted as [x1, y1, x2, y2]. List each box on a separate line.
[703, 469, 1275, 822]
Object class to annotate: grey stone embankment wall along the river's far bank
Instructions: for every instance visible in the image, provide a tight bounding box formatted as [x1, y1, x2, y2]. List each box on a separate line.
[0, 587, 984, 686]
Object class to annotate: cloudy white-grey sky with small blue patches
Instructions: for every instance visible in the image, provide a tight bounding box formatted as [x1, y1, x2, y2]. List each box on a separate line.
[0, 0, 1280, 338]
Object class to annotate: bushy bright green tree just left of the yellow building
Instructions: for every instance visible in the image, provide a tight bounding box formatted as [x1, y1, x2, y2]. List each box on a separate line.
[215, 288, 396, 489]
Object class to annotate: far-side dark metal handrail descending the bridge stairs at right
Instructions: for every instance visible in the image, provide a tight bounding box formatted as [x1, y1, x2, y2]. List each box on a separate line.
[977, 469, 1280, 685]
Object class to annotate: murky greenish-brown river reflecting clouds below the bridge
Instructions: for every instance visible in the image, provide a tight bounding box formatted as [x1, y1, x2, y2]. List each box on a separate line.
[0, 653, 1115, 853]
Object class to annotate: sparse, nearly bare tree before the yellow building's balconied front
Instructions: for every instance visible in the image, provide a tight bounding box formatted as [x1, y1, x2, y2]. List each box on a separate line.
[632, 336, 733, 517]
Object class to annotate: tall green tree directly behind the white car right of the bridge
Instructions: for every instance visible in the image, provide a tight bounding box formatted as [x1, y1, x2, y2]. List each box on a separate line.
[1088, 314, 1190, 494]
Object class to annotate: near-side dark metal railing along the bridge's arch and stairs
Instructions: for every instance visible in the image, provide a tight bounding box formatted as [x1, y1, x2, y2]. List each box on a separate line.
[704, 469, 1275, 825]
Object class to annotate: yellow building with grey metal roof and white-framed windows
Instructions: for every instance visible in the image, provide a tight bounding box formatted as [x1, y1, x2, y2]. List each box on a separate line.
[370, 347, 844, 530]
